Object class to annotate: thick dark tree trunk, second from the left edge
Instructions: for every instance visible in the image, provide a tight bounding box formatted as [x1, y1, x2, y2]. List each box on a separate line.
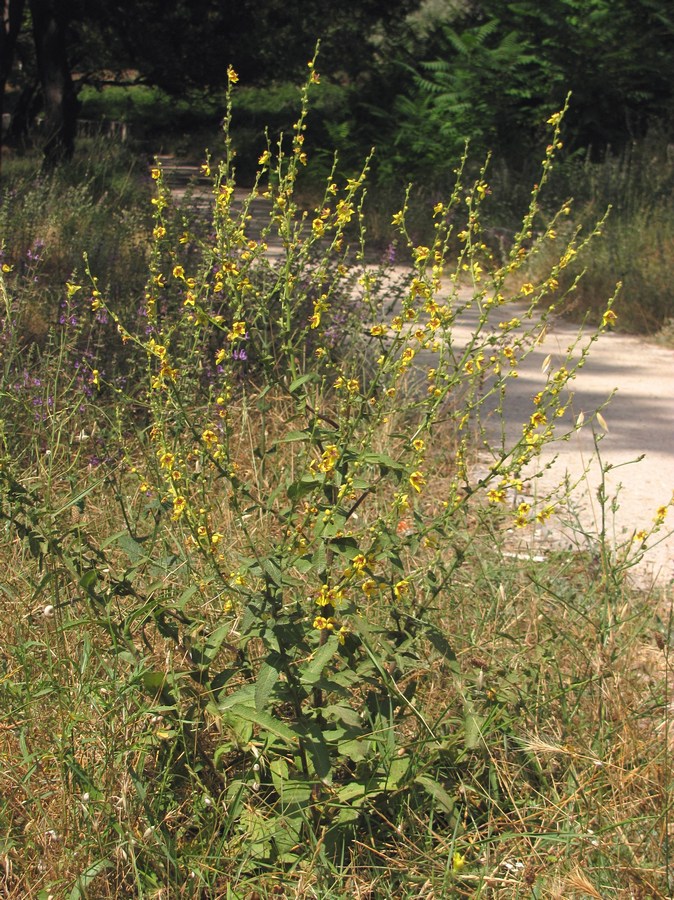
[29, 0, 78, 169]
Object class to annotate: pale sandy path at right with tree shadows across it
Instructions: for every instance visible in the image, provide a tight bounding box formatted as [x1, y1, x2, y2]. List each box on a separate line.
[440, 298, 674, 585]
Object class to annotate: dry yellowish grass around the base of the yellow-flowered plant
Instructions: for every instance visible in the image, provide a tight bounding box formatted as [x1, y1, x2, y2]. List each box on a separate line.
[0, 410, 672, 898]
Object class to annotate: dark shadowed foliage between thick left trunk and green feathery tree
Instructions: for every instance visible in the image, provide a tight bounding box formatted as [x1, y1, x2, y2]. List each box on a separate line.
[71, 0, 420, 94]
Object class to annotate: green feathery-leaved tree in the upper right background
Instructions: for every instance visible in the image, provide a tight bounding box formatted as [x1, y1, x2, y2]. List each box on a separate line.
[382, 0, 674, 185]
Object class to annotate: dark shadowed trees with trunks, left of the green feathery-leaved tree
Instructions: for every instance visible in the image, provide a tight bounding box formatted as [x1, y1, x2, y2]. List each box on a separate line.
[0, 0, 420, 165]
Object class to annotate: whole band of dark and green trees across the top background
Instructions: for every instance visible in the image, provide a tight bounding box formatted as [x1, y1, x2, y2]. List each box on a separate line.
[0, 0, 674, 168]
